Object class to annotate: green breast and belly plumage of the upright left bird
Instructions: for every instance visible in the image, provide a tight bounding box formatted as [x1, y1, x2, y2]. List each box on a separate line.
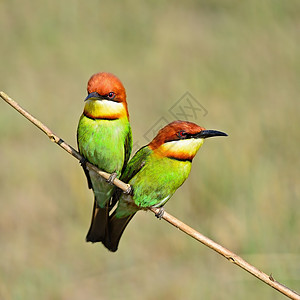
[77, 115, 132, 207]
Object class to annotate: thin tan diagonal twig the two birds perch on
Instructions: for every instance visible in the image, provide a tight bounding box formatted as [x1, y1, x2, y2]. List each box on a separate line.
[0, 92, 300, 300]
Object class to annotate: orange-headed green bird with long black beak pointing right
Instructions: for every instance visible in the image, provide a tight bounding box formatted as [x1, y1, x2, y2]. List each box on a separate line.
[104, 121, 227, 252]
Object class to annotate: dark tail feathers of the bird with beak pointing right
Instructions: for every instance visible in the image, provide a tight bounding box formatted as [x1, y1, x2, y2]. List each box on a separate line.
[103, 212, 135, 252]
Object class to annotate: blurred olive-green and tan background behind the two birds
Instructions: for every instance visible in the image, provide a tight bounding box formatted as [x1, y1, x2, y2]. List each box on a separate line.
[0, 0, 300, 300]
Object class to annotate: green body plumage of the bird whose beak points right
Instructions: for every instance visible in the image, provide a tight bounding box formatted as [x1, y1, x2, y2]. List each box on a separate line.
[116, 147, 191, 218]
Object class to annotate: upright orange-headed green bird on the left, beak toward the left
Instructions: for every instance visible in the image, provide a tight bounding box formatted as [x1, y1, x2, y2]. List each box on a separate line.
[77, 72, 132, 243]
